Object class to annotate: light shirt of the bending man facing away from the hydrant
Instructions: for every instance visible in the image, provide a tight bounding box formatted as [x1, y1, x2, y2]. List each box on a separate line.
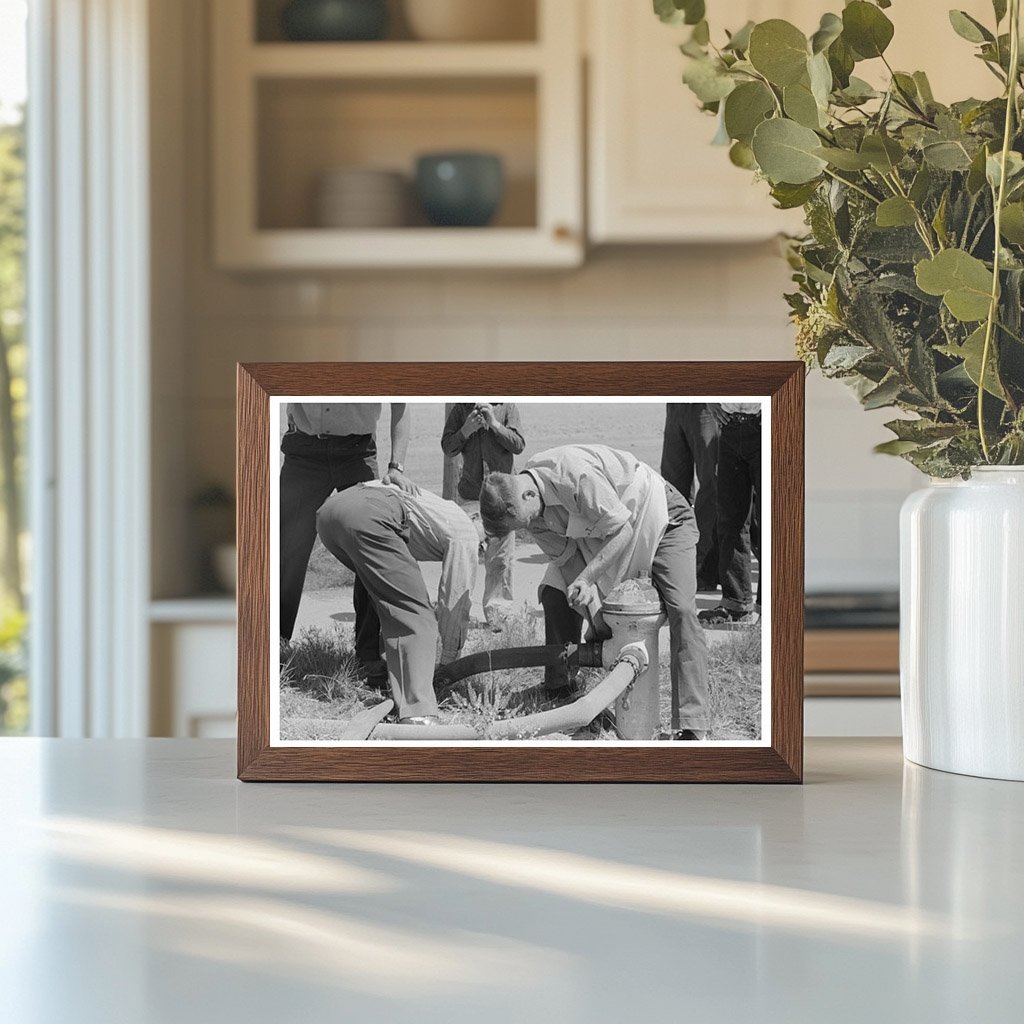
[364, 482, 480, 663]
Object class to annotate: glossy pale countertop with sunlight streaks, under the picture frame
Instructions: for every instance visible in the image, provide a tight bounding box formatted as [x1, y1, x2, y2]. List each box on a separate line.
[0, 739, 1024, 1024]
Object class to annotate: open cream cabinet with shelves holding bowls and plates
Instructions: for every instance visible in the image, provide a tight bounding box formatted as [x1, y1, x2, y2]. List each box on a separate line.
[212, 0, 584, 270]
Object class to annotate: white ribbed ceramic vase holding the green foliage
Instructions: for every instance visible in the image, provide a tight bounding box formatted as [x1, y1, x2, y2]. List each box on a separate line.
[900, 467, 1024, 781]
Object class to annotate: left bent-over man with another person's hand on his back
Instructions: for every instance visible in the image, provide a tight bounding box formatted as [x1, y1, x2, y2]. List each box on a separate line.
[316, 483, 480, 725]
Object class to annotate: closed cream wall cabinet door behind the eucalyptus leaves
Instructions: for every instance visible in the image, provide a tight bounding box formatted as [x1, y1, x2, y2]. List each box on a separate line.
[586, 0, 998, 244]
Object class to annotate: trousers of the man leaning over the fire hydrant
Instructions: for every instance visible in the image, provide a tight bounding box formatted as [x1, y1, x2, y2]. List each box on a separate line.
[541, 485, 711, 731]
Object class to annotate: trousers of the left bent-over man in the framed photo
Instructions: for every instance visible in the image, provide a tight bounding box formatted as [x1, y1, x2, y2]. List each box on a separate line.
[316, 487, 437, 718]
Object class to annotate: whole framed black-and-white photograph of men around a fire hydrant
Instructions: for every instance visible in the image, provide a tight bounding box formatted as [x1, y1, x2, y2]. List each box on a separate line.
[238, 362, 804, 782]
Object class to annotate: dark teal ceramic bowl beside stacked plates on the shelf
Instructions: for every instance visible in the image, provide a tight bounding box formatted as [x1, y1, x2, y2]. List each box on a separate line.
[416, 153, 505, 227]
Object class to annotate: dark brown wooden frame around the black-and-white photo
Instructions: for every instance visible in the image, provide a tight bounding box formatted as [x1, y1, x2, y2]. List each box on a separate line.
[238, 361, 805, 782]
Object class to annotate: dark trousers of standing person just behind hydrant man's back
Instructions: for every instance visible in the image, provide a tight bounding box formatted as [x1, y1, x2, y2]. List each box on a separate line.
[662, 402, 719, 585]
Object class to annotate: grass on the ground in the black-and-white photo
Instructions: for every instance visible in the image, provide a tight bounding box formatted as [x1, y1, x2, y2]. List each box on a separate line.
[281, 611, 761, 740]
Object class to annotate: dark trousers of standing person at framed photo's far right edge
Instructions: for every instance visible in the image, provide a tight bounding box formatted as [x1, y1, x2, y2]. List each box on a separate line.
[718, 413, 761, 612]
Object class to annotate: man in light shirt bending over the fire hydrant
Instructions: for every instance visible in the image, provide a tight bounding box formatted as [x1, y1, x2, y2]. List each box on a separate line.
[480, 444, 710, 739]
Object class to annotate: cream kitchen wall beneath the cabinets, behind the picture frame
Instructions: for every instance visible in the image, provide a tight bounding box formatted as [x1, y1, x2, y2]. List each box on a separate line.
[157, 0, 918, 593]
